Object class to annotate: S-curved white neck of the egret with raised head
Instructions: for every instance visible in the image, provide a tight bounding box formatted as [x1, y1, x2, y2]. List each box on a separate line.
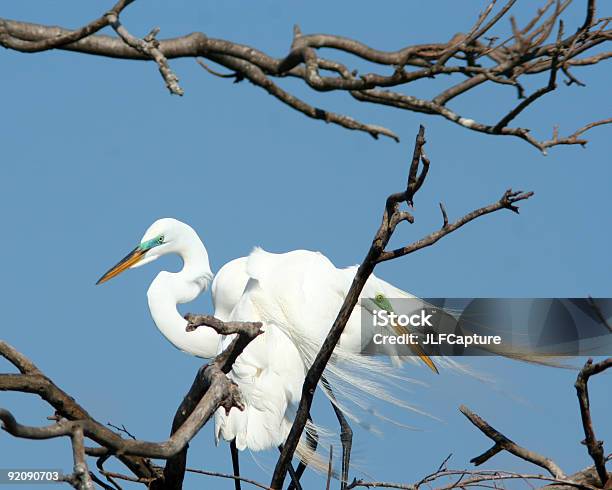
[147, 232, 219, 358]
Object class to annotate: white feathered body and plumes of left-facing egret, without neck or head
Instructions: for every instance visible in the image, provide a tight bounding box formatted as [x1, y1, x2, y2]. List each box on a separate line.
[213, 248, 450, 450]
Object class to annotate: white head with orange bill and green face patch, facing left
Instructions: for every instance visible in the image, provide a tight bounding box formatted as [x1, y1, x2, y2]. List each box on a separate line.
[96, 218, 190, 284]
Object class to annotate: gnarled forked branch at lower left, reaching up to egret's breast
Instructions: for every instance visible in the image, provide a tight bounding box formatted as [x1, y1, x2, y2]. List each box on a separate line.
[0, 316, 260, 489]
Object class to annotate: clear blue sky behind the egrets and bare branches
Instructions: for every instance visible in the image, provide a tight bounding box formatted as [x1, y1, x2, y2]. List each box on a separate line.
[0, 0, 612, 488]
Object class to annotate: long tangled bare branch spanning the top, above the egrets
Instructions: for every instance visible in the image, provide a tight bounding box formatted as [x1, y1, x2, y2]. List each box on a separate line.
[0, 0, 612, 153]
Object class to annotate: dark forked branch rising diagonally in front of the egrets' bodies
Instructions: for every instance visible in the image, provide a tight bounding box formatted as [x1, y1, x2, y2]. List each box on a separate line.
[270, 126, 532, 489]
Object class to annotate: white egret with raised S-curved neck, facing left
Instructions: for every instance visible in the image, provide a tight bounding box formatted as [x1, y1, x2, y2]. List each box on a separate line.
[97, 218, 436, 485]
